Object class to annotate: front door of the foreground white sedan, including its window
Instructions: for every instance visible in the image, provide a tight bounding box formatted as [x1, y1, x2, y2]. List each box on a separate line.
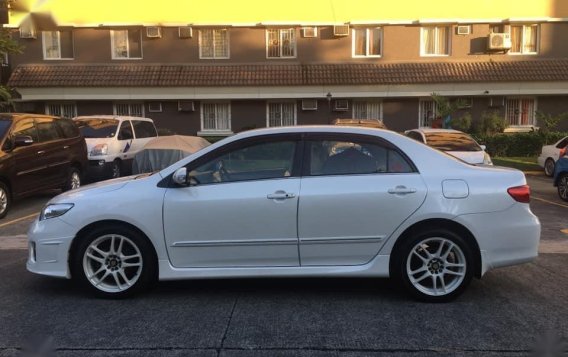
[163, 136, 301, 267]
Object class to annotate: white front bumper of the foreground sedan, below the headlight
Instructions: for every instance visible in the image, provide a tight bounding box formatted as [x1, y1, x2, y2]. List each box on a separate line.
[26, 218, 75, 279]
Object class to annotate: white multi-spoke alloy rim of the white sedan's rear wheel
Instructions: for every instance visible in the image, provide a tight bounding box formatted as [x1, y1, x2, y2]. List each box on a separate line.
[406, 237, 467, 296]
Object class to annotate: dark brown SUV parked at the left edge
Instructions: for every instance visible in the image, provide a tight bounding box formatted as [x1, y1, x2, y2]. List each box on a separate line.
[0, 113, 87, 218]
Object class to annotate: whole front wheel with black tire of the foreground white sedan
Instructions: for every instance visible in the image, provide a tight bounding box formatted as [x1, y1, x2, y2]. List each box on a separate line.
[70, 224, 157, 299]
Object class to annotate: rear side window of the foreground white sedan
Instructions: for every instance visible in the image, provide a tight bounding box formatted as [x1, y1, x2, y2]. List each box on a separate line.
[308, 140, 414, 176]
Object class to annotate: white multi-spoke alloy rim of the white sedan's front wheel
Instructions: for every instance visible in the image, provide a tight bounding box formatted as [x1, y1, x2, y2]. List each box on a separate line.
[83, 234, 143, 293]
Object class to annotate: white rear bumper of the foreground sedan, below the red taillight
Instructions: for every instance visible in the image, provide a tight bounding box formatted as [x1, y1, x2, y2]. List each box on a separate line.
[455, 203, 540, 275]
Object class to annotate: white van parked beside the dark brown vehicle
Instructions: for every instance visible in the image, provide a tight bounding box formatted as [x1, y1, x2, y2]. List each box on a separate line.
[73, 115, 158, 178]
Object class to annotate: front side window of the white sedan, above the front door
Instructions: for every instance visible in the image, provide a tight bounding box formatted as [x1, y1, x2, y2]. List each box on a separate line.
[190, 141, 296, 184]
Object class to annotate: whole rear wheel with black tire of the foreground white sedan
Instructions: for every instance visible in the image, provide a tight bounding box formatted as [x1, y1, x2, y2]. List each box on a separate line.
[391, 229, 474, 302]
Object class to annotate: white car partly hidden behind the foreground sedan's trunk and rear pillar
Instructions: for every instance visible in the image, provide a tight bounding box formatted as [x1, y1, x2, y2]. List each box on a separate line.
[405, 128, 493, 165]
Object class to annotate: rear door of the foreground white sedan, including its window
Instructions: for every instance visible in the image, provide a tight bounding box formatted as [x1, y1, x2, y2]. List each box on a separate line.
[298, 134, 426, 266]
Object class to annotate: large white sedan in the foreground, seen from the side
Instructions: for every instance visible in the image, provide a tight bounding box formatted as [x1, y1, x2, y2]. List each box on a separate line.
[27, 126, 540, 301]
